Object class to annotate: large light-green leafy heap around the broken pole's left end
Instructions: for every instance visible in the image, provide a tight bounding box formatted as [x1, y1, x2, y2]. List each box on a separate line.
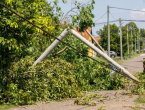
[0, 56, 80, 104]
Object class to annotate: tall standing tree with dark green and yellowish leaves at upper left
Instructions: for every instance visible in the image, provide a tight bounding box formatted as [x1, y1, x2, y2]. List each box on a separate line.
[0, 0, 54, 69]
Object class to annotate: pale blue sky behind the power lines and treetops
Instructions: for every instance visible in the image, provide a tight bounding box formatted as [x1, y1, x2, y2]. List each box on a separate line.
[47, 0, 145, 36]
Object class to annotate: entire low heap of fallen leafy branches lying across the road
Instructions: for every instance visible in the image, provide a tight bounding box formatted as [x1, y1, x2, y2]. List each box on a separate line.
[0, 56, 123, 104]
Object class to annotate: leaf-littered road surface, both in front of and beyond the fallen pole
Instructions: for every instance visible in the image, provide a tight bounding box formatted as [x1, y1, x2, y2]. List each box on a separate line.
[11, 54, 145, 110]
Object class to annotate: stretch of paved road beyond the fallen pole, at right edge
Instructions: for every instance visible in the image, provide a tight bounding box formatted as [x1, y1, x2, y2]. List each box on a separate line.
[121, 54, 145, 74]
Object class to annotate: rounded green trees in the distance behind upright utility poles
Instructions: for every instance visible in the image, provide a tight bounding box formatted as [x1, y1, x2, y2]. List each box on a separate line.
[97, 22, 142, 55]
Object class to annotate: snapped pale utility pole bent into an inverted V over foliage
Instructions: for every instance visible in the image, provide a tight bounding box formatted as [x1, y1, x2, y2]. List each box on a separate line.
[33, 29, 140, 83]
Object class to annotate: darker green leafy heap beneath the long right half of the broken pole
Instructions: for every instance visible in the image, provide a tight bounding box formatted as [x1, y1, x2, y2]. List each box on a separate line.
[74, 59, 124, 90]
